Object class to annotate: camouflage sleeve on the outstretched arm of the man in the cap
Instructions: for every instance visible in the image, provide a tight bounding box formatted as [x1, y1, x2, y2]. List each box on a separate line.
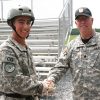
[48, 47, 70, 83]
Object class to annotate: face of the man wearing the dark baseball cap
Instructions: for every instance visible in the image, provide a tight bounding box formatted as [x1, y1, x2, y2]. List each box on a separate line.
[75, 16, 93, 38]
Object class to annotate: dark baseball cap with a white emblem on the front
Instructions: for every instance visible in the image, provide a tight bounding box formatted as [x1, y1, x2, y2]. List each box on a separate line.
[75, 7, 92, 20]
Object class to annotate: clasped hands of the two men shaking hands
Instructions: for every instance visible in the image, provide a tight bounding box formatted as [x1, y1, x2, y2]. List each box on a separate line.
[42, 79, 55, 95]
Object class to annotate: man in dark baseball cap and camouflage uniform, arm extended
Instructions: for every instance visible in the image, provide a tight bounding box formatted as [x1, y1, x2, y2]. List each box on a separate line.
[46, 7, 100, 100]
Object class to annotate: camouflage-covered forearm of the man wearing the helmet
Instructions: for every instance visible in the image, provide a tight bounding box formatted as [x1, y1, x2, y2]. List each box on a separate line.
[4, 75, 43, 95]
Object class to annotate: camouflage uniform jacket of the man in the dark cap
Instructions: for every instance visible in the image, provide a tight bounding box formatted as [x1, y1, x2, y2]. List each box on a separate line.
[48, 33, 100, 100]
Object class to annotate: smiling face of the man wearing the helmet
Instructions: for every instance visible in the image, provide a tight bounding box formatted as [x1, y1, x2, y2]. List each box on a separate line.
[14, 16, 31, 39]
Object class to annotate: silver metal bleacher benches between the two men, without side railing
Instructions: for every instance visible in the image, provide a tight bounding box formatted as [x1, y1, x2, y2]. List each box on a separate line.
[28, 19, 59, 80]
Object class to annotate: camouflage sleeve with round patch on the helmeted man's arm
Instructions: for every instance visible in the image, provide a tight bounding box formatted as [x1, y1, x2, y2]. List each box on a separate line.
[0, 48, 43, 95]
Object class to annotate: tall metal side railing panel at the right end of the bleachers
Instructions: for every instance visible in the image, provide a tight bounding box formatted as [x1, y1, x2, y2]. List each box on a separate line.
[58, 0, 72, 56]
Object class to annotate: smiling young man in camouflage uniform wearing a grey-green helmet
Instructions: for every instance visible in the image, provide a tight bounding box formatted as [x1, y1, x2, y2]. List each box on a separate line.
[0, 7, 48, 100]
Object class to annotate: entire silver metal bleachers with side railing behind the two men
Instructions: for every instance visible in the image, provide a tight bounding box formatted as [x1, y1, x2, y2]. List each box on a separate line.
[0, 0, 72, 79]
